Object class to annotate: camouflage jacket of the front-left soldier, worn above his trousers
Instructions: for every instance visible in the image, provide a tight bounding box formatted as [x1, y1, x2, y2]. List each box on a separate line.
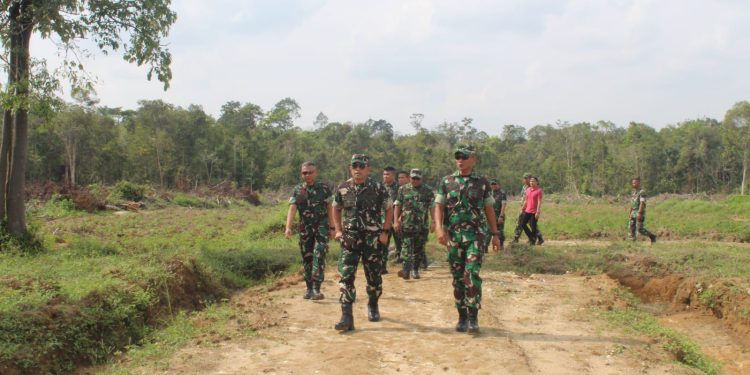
[333, 178, 393, 233]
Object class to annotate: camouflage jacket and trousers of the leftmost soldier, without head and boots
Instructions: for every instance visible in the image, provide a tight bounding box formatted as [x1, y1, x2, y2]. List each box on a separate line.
[289, 181, 332, 286]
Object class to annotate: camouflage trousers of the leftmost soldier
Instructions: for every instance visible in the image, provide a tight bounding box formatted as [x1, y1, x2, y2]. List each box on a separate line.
[299, 224, 328, 284]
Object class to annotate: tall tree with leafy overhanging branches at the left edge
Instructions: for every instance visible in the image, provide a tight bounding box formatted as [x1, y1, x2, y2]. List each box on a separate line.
[0, 0, 176, 237]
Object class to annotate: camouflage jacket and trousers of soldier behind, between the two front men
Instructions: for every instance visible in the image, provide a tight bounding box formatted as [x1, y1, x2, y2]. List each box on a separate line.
[393, 175, 435, 270]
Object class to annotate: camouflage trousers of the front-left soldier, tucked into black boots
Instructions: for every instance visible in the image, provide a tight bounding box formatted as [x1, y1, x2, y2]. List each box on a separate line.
[339, 232, 383, 303]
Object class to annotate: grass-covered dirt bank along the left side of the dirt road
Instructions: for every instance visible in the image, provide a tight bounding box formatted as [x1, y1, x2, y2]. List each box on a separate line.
[0, 260, 228, 374]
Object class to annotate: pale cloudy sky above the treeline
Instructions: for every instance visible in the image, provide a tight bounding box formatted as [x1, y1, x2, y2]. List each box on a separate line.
[32, 0, 750, 135]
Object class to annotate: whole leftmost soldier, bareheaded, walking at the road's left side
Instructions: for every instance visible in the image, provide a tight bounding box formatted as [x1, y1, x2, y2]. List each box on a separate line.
[284, 161, 332, 300]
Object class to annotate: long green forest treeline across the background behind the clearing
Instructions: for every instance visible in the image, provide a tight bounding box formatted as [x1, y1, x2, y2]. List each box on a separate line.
[27, 98, 750, 195]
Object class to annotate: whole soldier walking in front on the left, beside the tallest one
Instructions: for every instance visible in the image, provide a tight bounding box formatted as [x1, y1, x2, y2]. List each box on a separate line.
[333, 154, 393, 331]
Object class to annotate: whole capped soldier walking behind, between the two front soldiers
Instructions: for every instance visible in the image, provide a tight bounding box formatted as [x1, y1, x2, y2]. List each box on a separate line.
[393, 169, 435, 280]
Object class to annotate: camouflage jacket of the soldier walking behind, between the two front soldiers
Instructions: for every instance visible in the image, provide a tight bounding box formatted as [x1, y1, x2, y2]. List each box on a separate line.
[393, 184, 435, 232]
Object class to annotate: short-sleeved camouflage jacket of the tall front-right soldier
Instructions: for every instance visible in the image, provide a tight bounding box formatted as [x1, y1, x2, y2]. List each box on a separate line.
[435, 172, 495, 231]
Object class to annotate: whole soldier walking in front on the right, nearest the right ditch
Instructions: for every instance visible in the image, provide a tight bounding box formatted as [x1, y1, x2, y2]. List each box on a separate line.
[435, 144, 500, 333]
